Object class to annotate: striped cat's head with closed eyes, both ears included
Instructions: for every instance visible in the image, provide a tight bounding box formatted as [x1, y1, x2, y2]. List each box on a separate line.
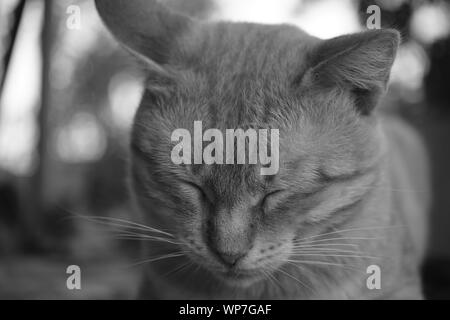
[96, 0, 399, 285]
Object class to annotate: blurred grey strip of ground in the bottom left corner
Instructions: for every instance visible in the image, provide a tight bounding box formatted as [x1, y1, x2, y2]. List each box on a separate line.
[0, 256, 138, 299]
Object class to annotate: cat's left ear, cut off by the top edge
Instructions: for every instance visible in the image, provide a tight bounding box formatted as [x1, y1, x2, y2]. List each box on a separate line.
[95, 0, 194, 64]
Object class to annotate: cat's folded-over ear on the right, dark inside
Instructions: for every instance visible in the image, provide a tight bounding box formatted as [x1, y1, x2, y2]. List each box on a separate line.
[304, 29, 400, 114]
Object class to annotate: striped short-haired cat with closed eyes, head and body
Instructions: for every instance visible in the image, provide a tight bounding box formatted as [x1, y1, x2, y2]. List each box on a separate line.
[96, 0, 429, 299]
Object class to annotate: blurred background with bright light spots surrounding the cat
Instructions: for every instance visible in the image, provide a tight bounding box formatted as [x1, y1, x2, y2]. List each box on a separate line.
[0, 0, 450, 299]
